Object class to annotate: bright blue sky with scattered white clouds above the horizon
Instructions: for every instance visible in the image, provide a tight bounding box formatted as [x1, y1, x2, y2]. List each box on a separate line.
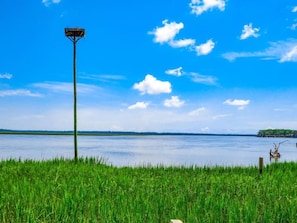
[0, 0, 297, 133]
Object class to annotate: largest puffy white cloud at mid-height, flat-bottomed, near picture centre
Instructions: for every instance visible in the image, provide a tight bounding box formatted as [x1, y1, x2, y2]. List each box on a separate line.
[133, 74, 171, 94]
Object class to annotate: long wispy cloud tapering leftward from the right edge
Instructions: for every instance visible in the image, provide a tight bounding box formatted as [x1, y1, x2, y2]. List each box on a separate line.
[222, 39, 297, 63]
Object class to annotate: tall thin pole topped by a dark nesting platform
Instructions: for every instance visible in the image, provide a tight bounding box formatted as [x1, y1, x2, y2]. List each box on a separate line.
[65, 28, 85, 160]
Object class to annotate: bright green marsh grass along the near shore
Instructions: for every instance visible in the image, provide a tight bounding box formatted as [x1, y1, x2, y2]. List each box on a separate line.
[0, 158, 297, 223]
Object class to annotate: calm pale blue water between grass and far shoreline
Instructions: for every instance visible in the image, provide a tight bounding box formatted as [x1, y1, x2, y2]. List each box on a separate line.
[0, 135, 297, 166]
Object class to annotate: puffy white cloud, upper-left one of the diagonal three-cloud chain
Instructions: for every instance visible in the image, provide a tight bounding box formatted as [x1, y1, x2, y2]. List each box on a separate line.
[149, 19, 184, 43]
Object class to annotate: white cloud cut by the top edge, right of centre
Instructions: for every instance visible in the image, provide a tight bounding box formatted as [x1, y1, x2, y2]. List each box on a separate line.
[189, 0, 225, 15]
